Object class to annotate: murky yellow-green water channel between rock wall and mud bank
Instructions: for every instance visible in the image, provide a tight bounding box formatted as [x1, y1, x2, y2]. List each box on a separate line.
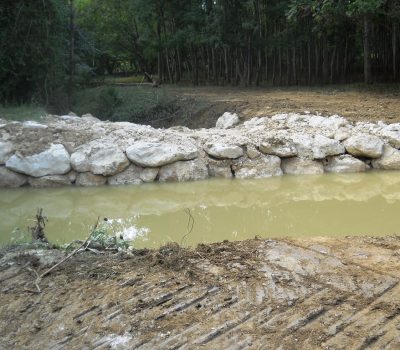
[0, 172, 400, 247]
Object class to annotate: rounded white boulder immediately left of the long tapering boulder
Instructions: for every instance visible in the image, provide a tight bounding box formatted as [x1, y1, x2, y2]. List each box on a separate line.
[90, 146, 129, 176]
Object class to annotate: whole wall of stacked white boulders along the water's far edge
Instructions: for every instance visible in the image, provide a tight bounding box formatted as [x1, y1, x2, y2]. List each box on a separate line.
[0, 113, 400, 187]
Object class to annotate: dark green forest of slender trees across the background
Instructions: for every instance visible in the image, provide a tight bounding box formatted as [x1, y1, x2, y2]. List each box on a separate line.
[0, 0, 400, 104]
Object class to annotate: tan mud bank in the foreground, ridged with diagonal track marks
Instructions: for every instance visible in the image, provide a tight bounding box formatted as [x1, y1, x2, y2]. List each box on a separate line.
[0, 236, 400, 349]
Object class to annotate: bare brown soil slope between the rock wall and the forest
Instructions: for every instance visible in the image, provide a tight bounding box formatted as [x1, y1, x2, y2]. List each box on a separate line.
[162, 86, 400, 128]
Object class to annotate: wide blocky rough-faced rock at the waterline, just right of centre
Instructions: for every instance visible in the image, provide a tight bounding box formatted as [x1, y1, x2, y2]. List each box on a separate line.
[232, 155, 282, 179]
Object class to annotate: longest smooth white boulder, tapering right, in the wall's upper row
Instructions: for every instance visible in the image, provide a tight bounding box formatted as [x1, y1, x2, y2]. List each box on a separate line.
[126, 141, 198, 167]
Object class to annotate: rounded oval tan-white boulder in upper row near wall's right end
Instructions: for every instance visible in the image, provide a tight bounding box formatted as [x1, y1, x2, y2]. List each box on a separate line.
[344, 133, 384, 158]
